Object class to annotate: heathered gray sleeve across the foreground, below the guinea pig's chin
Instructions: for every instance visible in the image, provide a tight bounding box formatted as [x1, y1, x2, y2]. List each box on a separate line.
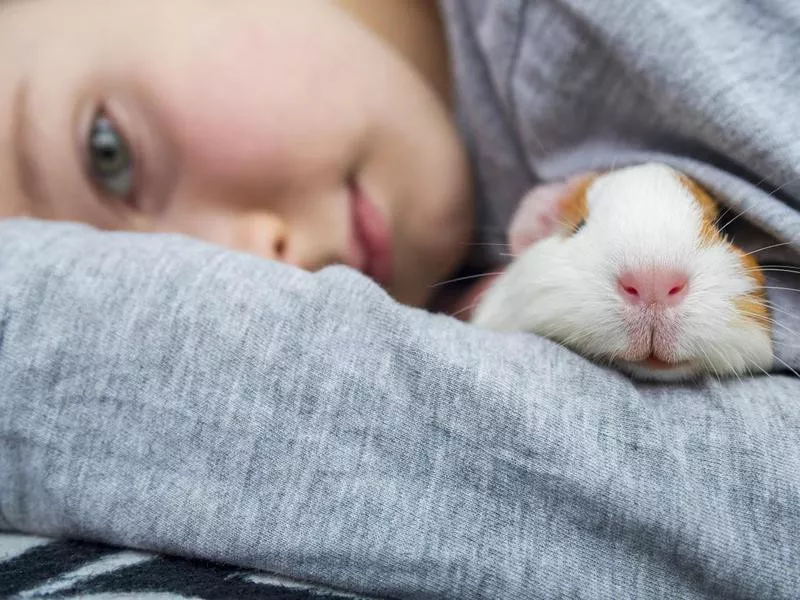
[0, 221, 800, 600]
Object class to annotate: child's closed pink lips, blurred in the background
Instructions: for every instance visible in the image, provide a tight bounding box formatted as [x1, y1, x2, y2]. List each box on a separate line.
[349, 181, 392, 285]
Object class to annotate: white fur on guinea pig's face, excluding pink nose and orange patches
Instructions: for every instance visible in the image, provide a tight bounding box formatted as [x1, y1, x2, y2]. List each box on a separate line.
[473, 164, 772, 380]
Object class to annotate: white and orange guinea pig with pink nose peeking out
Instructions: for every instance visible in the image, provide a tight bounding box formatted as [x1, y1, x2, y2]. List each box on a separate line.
[472, 163, 773, 381]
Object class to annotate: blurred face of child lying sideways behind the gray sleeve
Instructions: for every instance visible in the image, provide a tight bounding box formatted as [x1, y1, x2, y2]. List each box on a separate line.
[0, 0, 472, 304]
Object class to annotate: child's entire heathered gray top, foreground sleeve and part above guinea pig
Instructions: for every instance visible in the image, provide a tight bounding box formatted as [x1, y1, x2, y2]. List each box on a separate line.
[0, 0, 800, 600]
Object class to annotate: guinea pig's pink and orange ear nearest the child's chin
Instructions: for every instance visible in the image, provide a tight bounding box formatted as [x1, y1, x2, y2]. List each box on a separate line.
[508, 173, 597, 256]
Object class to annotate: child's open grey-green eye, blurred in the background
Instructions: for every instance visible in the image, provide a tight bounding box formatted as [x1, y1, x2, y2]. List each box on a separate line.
[86, 111, 134, 200]
